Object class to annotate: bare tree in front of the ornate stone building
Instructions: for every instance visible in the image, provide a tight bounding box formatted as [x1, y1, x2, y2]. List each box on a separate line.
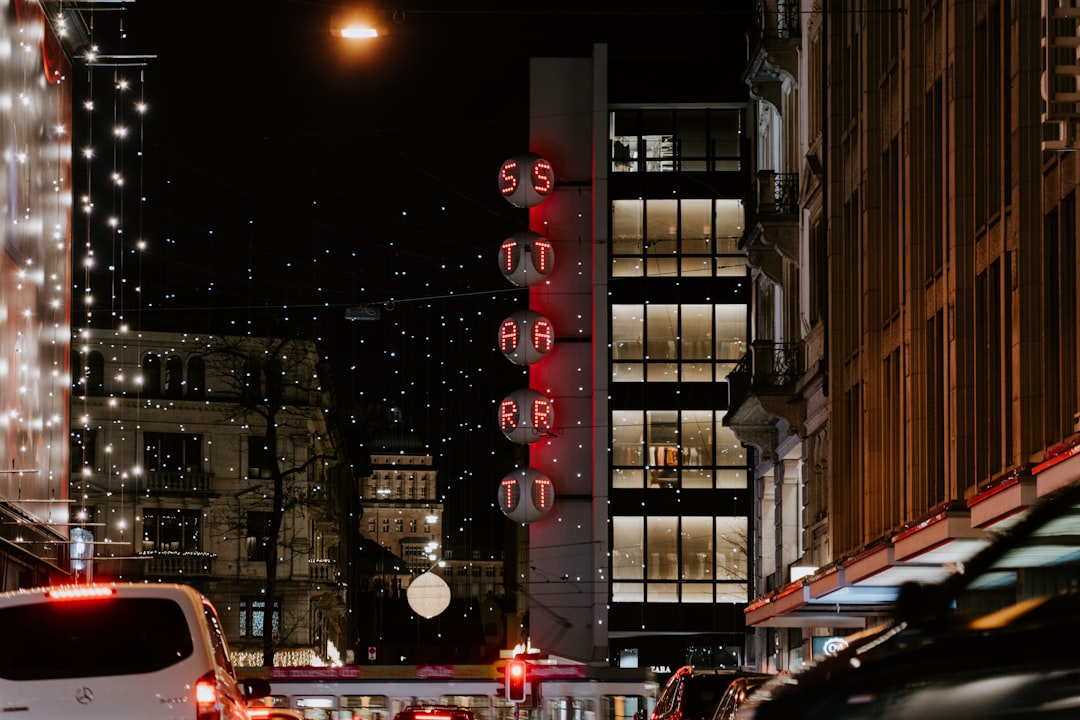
[206, 337, 337, 666]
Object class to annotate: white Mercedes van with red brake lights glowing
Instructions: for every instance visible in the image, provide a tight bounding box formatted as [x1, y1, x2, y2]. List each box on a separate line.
[0, 583, 269, 720]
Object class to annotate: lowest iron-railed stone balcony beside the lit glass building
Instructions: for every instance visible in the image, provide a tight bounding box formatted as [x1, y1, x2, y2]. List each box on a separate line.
[724, 340, 806, 457]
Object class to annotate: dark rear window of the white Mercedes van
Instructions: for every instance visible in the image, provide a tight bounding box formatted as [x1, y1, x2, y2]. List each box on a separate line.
[0, 597, 194, 680]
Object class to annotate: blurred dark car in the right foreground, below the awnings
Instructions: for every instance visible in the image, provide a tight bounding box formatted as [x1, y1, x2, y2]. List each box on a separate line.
[737, 485, 1080, 720]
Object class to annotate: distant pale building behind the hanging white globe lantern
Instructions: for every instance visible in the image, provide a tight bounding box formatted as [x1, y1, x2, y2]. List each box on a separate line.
[356, 433, 513, 663]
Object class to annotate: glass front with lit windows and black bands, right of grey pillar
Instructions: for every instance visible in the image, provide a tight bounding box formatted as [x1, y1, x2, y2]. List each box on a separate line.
[607, 105, 752, 664]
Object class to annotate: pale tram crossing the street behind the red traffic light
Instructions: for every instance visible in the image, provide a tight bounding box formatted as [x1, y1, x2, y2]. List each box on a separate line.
[246, 661, 661, 720]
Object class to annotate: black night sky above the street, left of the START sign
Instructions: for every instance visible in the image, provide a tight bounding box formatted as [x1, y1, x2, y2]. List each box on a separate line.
[72, 0, 751, 544]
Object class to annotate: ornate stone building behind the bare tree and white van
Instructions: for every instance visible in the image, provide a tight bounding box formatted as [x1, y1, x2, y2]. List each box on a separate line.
[70, 329, 353, 665]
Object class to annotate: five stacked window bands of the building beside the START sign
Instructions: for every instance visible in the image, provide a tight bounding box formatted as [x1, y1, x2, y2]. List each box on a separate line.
[609, 127, 750, 604]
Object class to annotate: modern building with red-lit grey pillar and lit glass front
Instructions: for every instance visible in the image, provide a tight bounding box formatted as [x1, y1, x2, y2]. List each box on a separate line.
[511, 28, 754, 668]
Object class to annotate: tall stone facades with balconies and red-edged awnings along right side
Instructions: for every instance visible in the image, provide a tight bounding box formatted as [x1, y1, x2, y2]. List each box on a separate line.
[727, 0, 1080, 669]
